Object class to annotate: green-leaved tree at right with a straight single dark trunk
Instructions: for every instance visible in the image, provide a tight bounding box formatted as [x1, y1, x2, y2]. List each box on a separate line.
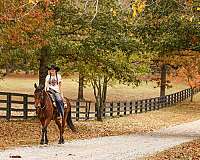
[133, 0, 199, 96]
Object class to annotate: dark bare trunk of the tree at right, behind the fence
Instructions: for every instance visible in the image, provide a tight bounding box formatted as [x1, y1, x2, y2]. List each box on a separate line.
[160, 64, 167, 97]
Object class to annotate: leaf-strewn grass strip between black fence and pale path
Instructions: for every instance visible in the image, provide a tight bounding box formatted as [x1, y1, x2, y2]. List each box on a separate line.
[0, 94, 200, 149]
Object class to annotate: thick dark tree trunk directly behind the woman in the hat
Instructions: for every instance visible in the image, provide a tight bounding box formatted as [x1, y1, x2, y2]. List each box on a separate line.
[39, 47, 48, 86]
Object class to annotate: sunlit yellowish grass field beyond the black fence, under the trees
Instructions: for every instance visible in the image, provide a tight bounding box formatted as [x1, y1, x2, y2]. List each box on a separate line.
[0, 75, 187, 101]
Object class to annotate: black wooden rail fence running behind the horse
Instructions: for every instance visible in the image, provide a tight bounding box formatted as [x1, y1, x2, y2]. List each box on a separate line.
[0, 88, 200, 121]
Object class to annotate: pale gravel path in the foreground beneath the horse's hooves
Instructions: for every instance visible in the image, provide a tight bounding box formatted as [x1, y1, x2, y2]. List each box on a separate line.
[0, 120, 200, 160]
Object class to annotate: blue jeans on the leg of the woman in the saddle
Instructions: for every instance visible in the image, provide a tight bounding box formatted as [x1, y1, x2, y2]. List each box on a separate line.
[49, 89, 64, 117]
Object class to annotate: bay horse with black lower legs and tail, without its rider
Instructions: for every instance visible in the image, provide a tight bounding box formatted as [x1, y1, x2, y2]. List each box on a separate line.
[34, 83, 75, 144]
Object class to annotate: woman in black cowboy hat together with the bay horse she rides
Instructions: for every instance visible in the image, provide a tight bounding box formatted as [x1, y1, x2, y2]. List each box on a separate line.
[34, 65, 76, 144]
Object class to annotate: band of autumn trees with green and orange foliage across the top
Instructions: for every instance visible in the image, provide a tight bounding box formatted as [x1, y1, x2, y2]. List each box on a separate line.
[0, 0, 200, 119]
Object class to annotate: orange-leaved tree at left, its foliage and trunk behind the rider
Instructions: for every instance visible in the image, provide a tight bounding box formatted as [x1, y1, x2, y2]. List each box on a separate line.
[0, 1, 54, 84]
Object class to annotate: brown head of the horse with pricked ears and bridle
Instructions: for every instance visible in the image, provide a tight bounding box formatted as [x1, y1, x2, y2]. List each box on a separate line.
[34, 83, 44, 114]
